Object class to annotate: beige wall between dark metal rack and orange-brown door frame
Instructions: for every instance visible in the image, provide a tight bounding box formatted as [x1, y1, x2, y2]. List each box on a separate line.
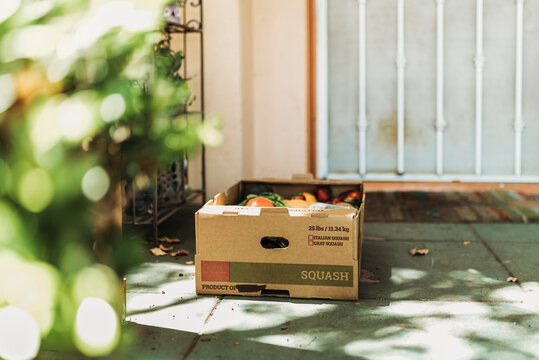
[201, 0, 307, 196]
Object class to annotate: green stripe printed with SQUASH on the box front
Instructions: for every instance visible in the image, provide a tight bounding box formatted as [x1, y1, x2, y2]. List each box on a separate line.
[230, 262, 355, 287]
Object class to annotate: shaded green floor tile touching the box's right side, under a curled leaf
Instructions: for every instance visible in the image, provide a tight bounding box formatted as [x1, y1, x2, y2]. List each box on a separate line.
[359, 241, 516, 300]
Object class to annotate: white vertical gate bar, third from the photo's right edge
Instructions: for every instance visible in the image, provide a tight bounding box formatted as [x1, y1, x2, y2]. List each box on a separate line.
[435, 0, 446, 175]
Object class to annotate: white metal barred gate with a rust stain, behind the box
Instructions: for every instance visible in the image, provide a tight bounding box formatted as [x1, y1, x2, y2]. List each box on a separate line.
[316, 0, 539, 182]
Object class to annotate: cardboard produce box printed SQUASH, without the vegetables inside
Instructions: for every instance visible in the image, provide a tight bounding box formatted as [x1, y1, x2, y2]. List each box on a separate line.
[195, 178, 365, 300]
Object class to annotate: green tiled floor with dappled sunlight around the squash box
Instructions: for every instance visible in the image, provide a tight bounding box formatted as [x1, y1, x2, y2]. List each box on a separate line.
[127, 205, 539, 359]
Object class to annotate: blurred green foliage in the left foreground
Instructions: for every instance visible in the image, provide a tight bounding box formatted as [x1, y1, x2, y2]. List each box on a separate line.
[0, 0, 222, 358]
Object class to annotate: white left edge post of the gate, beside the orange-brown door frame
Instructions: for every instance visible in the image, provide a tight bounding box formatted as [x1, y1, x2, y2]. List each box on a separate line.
[316, 0, 329, 178]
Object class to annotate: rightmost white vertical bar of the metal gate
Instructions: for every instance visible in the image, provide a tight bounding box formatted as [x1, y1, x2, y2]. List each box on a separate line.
[513, 0, 525, 176]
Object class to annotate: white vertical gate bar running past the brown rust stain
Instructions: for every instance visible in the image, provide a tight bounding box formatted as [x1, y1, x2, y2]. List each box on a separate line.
[396, 0, 406, 175]
